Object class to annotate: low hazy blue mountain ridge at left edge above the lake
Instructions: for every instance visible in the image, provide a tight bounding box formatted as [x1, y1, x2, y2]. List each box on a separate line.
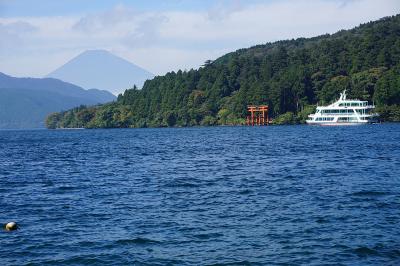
[0, 72, 115, 128]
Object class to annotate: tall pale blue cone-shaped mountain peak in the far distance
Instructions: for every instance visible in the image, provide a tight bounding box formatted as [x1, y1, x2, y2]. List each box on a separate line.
[46, 50, 154, 94]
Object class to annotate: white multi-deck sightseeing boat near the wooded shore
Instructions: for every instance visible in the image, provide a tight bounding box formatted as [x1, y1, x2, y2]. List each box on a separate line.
[306, 90, 378, 126]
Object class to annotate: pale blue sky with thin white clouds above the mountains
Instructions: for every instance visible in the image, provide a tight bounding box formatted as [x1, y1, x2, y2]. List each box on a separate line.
[0, 0, 400, 84]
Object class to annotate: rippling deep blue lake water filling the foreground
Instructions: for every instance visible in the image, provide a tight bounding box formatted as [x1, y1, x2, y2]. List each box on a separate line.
[0, 124, 400, 265]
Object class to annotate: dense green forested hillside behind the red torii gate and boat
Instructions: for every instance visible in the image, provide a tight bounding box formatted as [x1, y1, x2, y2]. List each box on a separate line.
[46, 15, 400, 128]
